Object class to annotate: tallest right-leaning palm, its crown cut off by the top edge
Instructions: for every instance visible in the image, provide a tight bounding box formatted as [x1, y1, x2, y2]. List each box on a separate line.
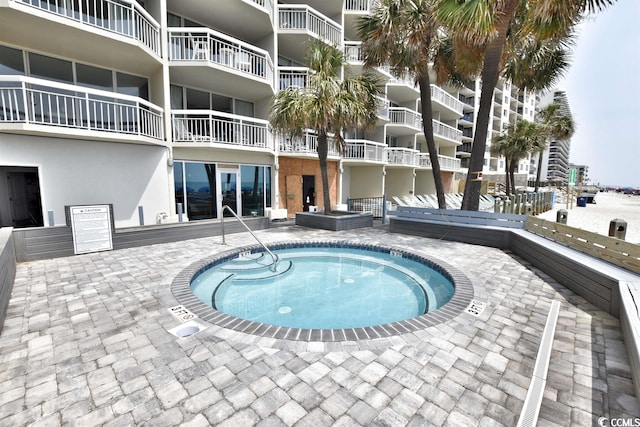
[437, 0, 615, 210]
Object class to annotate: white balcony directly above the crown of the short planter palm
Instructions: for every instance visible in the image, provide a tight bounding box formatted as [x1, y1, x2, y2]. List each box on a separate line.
[278, 5, 342, 62]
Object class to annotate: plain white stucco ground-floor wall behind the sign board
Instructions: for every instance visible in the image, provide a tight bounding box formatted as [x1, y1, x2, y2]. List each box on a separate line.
[0, 134, 173, 227]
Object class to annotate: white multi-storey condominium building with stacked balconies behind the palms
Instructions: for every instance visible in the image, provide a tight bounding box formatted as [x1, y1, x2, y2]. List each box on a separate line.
[0, 0, 535, 227]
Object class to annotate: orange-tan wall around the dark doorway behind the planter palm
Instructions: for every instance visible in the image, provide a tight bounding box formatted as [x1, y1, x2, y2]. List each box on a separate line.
[278, 157, 338, 216]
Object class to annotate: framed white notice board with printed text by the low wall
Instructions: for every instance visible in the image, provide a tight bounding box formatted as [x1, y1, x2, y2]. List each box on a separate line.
[70, 205, 113, 254]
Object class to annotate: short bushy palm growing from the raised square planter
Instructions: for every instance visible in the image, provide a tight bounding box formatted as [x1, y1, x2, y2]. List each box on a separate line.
[270, 40, 379, 214]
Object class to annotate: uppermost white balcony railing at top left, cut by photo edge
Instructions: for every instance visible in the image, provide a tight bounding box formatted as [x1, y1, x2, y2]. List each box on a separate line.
[22, 0, 160, 56]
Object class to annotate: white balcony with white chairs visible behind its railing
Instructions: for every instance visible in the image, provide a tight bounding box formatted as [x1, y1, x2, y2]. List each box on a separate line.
[169, 28, 274, 100]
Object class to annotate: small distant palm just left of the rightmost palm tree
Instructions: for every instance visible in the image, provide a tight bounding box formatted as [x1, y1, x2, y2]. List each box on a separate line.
[491, 120, 545, 196]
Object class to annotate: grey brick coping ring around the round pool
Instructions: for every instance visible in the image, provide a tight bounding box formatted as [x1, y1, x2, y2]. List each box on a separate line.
[171, 239, 474, 342]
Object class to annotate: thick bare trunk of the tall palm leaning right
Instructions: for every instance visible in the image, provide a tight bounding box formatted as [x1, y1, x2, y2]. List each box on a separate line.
[462, 0, 518, 211]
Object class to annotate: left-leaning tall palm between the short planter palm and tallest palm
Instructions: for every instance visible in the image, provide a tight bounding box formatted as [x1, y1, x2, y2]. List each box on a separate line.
[358, 0, 468, 209]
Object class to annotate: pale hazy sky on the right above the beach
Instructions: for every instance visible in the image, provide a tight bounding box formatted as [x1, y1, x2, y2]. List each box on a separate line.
[556, 0, 640, 188]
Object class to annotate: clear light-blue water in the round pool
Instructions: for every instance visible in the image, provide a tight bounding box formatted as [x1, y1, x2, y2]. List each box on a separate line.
[191, 247, 454, 329]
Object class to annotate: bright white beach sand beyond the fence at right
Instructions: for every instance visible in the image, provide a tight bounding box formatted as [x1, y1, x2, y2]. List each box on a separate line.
[538, 192, 640, 244]
